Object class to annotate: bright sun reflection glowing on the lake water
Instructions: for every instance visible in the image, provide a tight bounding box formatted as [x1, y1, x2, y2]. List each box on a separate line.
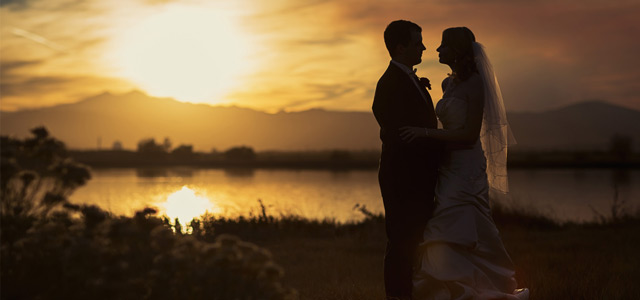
[162, 186, 219, 224]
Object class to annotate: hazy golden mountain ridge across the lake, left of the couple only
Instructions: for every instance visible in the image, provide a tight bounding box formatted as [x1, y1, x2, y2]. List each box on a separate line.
[0, 91, 379, 151]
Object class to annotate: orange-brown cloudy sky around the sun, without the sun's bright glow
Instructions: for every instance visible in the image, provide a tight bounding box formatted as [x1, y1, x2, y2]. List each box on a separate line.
[0, 0, 640, 111]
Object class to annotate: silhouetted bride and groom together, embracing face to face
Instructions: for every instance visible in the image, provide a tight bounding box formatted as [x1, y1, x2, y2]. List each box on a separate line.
[373, 20, 528, 300]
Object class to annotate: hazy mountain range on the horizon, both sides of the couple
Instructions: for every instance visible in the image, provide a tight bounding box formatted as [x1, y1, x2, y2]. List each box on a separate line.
[0, 91, 640, 151]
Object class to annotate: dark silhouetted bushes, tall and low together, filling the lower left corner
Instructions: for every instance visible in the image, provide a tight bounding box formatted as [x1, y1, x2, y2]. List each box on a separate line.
[0, 128, 297, 299]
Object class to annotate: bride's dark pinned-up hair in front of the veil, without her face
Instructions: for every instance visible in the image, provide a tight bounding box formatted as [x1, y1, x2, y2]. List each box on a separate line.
[442, 27, 478, 82]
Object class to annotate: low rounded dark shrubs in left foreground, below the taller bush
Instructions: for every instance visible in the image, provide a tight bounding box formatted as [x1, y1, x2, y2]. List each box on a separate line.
[1, 205, 297, 299]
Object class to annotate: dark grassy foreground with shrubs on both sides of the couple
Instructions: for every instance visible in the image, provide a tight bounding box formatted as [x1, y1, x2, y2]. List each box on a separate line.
[2, 199, 640, 299]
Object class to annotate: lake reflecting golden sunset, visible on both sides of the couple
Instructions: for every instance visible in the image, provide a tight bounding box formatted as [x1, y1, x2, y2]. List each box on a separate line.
[71, 167, 640, 222]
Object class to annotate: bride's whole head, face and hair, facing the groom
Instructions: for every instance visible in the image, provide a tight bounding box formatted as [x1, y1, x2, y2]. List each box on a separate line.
[436, 27, 478, 81]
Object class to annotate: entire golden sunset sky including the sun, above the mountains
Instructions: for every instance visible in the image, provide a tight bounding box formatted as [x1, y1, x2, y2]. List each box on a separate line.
[0, 0, 640, 112]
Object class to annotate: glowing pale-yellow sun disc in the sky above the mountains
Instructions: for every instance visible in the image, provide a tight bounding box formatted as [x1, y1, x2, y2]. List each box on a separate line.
[112, 5, 249, 104]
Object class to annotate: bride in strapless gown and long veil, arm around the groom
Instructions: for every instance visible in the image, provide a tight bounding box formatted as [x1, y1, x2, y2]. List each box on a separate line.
[401, 27, 529, 299]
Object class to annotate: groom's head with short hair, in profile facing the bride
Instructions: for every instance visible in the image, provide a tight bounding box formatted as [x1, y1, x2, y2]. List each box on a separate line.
[384, 20, 425, 66]
